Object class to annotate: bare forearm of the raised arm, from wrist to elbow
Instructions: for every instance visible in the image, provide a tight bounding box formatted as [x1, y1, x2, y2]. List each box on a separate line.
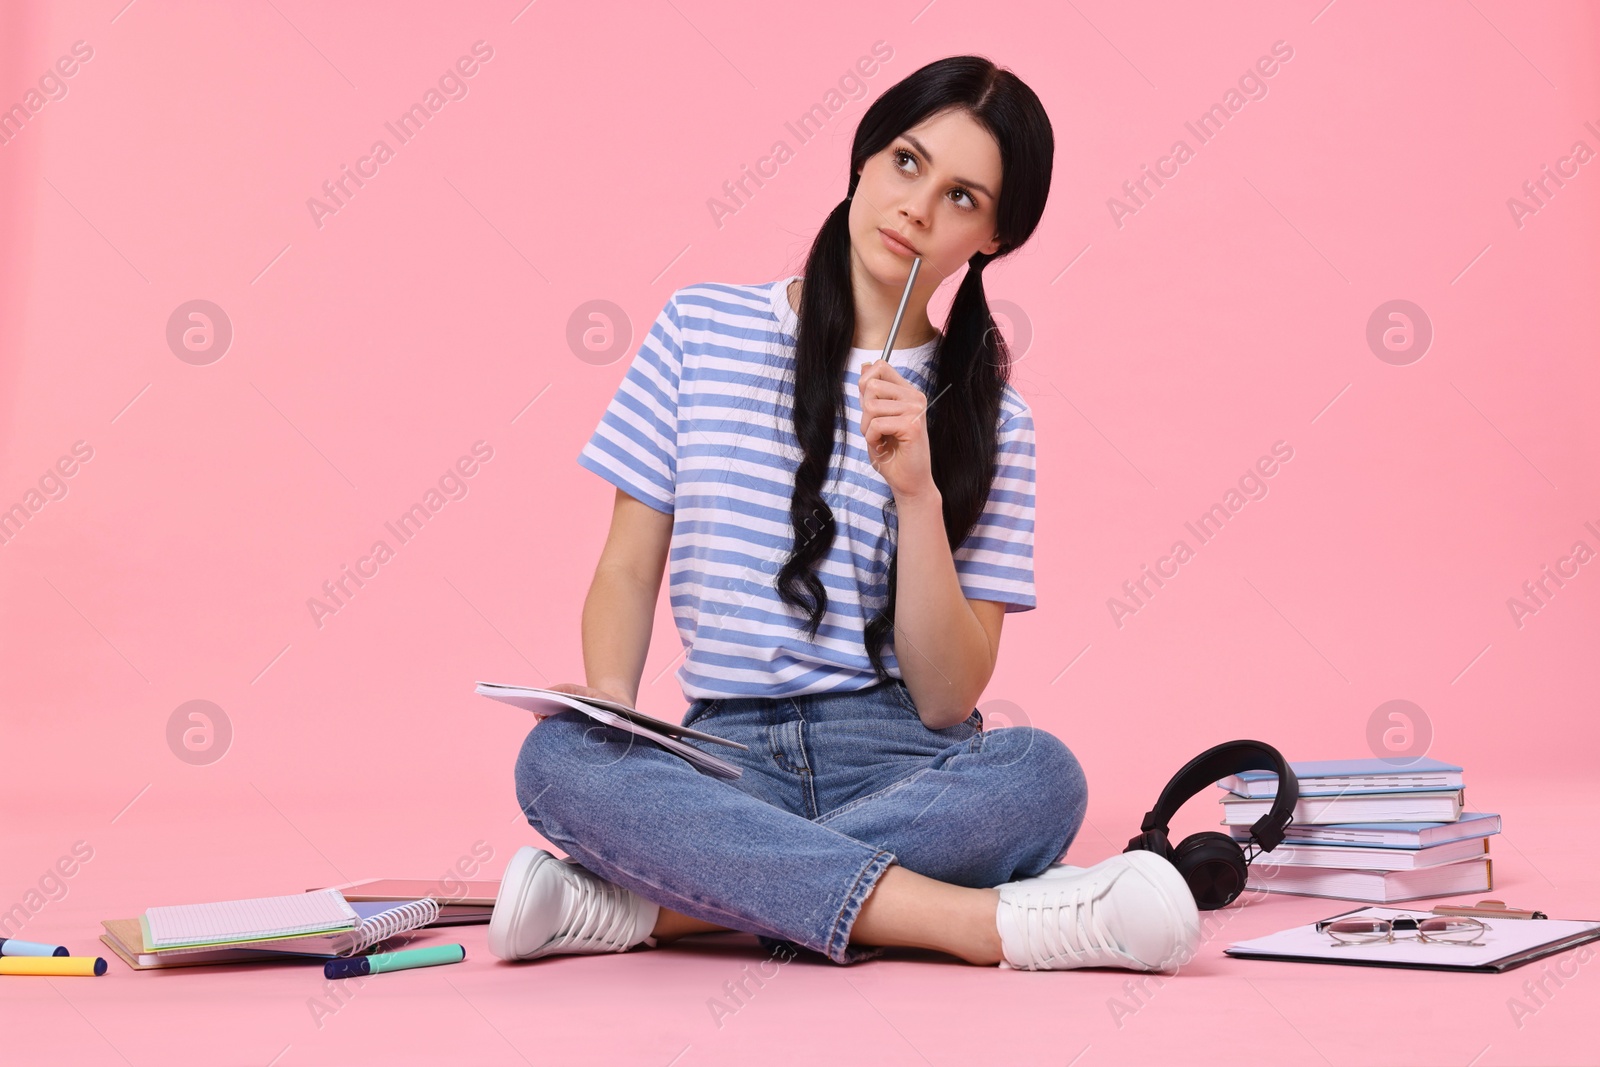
[894, 493, 994, 729]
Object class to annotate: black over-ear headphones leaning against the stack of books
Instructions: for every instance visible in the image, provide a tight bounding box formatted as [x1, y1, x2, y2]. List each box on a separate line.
[1122, 741, 1299, 912]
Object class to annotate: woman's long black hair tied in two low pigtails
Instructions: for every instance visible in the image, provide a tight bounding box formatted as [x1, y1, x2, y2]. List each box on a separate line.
[776, 56, 1056, 680]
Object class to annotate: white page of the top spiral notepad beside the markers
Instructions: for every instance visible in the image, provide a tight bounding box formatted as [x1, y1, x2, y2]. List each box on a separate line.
[139, 889, 362, 952]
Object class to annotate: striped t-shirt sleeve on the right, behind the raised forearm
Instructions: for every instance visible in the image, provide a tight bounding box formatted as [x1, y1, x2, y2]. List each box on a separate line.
[950, 410, 1038, 611]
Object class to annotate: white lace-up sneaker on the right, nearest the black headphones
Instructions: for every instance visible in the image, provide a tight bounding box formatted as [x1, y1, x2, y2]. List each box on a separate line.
[995, 851, 1200, 971]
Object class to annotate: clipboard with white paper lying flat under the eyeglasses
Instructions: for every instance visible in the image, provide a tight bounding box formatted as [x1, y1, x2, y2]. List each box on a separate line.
[1222, 907, 1600, 974]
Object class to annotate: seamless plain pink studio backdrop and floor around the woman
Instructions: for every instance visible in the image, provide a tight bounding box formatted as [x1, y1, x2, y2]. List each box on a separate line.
[0, 0, 1600, 1067]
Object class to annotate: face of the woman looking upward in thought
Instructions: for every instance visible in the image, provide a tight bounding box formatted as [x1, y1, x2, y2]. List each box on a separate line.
[850, 110, 1002, 290]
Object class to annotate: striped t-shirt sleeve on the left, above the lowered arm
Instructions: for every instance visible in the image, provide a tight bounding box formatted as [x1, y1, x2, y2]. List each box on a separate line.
[578, 294, 683, 515]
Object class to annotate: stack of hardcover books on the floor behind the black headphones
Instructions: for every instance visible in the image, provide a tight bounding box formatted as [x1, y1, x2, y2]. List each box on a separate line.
[1218, 758, 1501, 904]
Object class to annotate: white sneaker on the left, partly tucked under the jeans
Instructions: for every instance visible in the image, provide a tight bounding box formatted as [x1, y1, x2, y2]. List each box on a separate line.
[490, 845, 661, 960]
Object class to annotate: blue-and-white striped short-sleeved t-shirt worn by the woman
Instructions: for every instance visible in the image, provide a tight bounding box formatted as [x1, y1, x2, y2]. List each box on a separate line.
[578, 275, 1037, 701]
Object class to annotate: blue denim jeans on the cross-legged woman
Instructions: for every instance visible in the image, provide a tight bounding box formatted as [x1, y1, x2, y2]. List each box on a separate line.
[517, 678, 1088, 965]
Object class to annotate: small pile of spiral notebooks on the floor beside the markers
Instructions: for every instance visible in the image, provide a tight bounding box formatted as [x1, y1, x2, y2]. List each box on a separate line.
[101, 889, 438, 971]
